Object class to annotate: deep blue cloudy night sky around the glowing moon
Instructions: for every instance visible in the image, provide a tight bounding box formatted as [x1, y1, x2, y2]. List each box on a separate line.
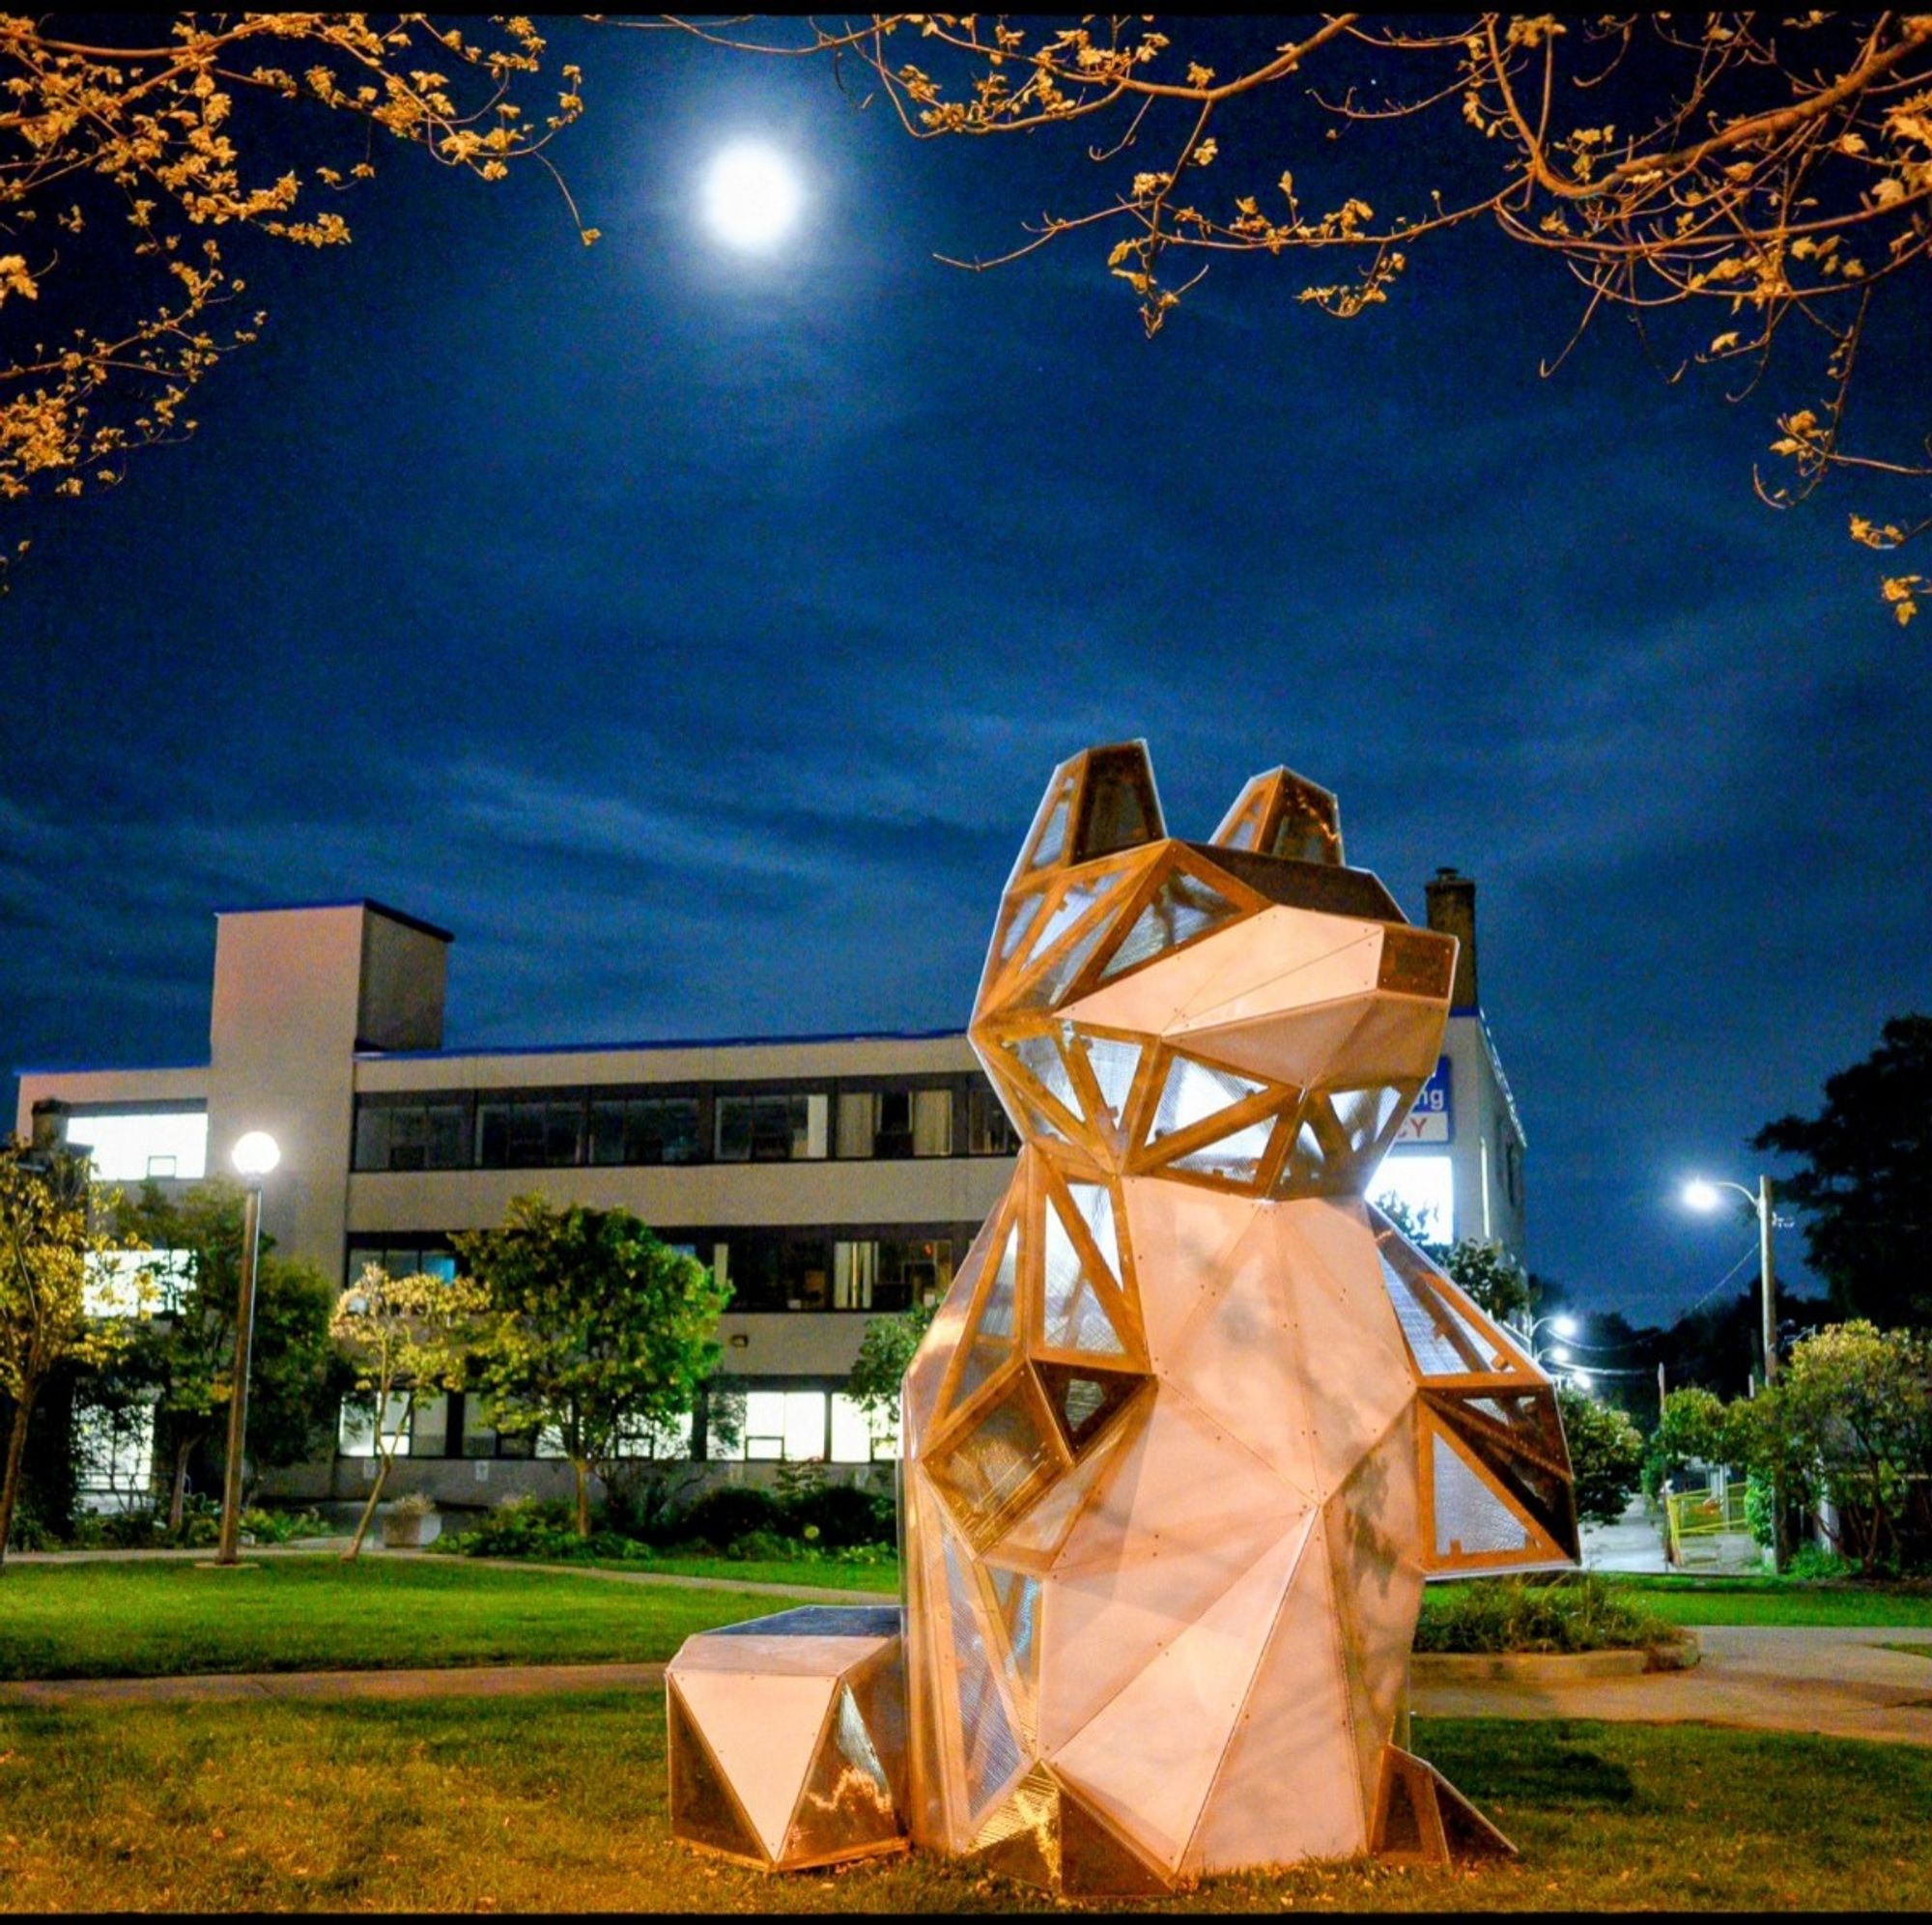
[0, 25, 1932, 1320]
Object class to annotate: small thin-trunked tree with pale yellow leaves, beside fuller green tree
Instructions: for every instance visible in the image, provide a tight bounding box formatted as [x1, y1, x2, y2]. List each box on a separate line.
[328, 1264, 489, 1560]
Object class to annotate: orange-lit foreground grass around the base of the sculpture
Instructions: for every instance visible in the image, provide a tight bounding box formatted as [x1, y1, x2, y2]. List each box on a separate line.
[0, 1691, 1932, 1913]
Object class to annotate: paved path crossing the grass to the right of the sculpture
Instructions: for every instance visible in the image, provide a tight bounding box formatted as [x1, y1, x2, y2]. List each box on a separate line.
[1412, 1626, 1932, 1745]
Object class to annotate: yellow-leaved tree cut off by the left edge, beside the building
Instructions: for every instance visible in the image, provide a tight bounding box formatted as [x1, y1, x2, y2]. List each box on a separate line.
[0, 1139, 141, 1570]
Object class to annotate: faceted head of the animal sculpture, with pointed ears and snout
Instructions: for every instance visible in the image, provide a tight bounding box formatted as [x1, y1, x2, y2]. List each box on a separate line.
[972, 742, 1457, 1197]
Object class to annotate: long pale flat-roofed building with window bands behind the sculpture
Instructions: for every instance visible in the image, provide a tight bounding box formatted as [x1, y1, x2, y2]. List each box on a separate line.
[17, 871, 1522, 1504]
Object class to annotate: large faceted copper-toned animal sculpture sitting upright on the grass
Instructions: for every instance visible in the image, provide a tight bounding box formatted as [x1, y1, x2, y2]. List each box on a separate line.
[672, 742, 1577, 1896]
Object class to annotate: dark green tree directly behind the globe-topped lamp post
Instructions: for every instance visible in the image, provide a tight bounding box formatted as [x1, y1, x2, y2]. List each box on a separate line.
[112, 1177, 346, 1531]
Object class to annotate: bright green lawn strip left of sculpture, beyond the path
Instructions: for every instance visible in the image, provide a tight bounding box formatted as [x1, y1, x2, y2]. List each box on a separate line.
[0, 1556, 831, 1678]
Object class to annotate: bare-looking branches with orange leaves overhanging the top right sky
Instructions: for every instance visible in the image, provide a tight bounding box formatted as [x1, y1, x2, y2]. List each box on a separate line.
[670, 12, 1932, 622]
